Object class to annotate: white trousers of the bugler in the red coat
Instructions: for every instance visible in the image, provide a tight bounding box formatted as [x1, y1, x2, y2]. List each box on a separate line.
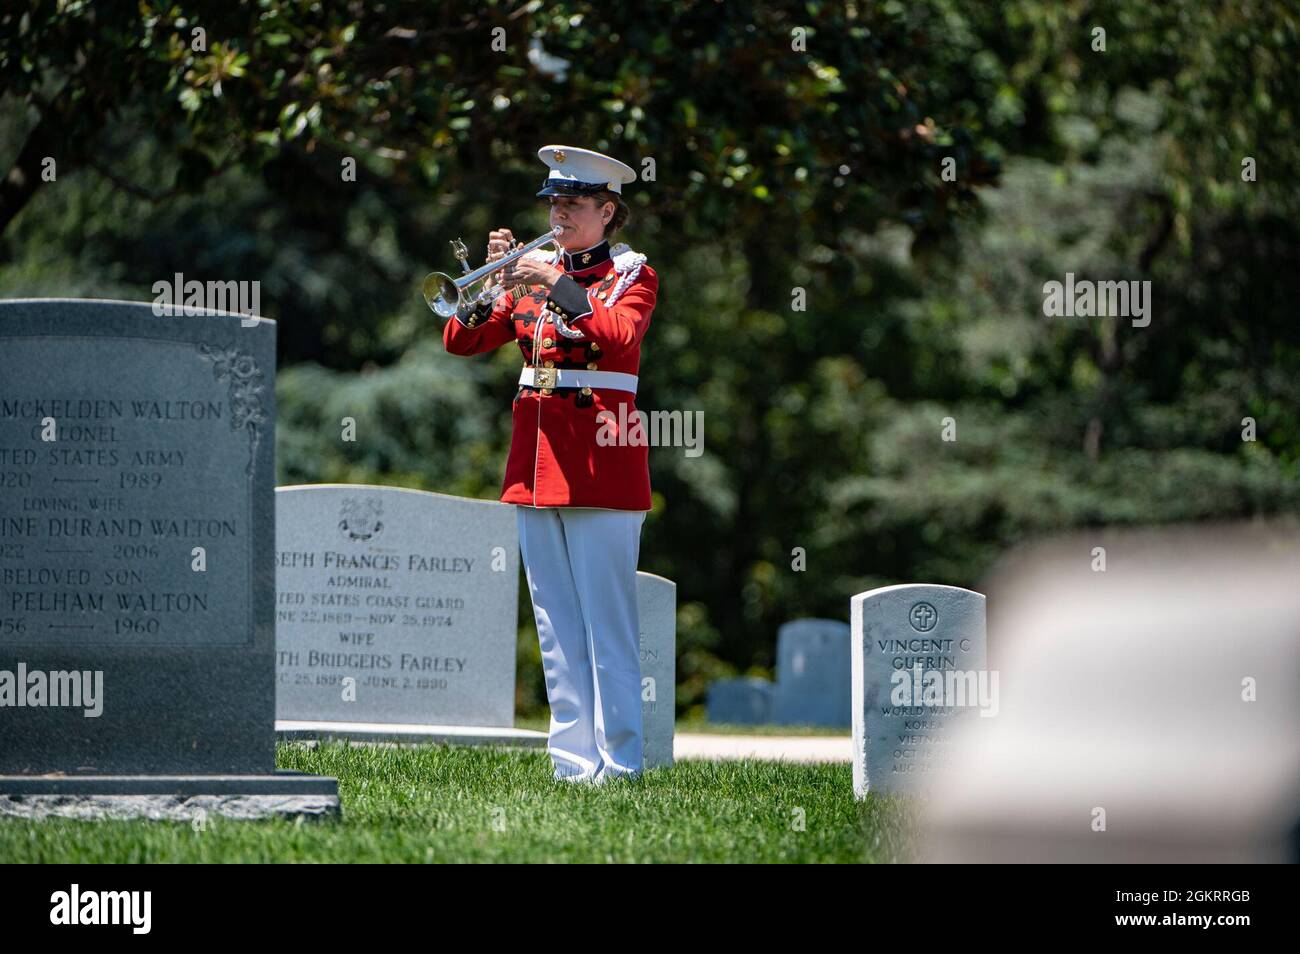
[516, 506, 646, 782]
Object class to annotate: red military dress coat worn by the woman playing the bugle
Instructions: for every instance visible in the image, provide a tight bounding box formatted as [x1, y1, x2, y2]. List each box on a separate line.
[442, 242, 659, 511]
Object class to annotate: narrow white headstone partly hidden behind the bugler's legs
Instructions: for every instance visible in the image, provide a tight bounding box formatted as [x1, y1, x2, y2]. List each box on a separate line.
[637, 572, 677, 768]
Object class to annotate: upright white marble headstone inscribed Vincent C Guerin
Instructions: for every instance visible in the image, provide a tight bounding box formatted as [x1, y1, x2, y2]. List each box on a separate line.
[849, 584, 988, 798]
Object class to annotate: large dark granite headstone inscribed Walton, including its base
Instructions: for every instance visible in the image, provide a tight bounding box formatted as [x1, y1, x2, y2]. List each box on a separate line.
[0, 299, 338, 818]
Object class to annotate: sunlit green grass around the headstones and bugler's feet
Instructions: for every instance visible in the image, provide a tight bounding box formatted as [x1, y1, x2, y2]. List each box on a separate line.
[0, 743, 907, 863]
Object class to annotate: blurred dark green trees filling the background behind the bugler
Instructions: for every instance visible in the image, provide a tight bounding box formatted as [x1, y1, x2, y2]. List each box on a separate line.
[0, 0, 1300, 712]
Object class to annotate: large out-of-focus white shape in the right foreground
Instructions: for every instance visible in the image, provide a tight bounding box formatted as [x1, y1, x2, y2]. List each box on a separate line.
[922, 522, 1300, 862]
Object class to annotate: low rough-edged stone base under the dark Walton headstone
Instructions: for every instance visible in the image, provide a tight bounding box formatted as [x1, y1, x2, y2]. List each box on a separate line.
[0, 769, 339, 821]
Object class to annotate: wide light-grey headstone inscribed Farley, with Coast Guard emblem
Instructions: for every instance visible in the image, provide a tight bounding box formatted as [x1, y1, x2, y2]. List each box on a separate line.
[276, 483, 519, 727]
